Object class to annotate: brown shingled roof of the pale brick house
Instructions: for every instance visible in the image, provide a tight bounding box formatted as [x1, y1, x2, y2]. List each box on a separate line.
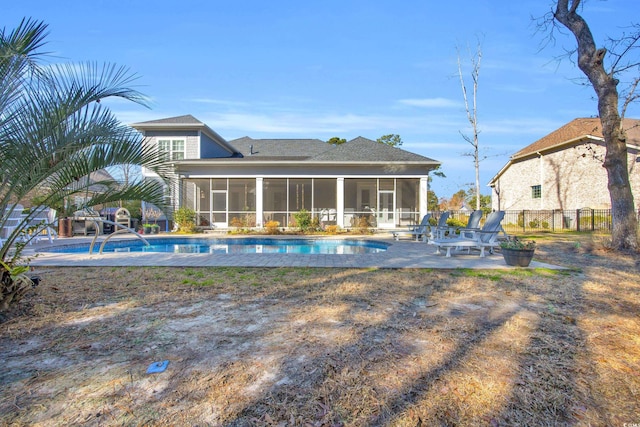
[511, 118, 640, 160]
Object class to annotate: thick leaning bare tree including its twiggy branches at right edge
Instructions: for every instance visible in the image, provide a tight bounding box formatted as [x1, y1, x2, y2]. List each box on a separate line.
[547, 0, 640, 250]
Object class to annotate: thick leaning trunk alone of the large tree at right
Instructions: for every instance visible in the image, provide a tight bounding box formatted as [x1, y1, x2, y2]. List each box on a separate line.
[554, 0, 638, 250]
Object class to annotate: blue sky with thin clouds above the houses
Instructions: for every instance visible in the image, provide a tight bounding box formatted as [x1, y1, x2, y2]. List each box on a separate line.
[5, 0, 640, 197]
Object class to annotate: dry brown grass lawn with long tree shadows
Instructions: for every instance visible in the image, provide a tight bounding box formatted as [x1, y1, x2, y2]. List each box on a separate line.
[0, 236, 640, 427]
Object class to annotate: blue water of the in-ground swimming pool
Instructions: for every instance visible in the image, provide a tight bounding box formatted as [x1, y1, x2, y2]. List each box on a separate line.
[47, 237, 388, 254]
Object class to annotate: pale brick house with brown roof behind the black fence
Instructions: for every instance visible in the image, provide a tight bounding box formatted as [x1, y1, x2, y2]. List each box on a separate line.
[489, 118, 640, 210]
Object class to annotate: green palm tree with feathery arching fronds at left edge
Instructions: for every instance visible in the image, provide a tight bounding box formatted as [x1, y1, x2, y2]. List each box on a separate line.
[0, 19, 168, 309]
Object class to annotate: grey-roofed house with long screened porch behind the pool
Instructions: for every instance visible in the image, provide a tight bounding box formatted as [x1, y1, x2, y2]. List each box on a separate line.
[131, 115, 440, 228]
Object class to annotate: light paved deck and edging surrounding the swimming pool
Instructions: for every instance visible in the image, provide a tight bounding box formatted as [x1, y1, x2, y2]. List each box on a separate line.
[23, 232, 564, 269]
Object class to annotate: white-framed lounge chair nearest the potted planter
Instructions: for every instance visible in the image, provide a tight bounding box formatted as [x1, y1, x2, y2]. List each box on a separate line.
[428, 211, 504, 257]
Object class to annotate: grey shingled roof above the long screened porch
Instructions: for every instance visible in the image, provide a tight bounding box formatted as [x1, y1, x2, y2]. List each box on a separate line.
[229, 136, 440, 165]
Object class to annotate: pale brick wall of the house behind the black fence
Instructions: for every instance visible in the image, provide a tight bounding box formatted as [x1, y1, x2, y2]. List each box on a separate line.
[492, 141, 640, 210]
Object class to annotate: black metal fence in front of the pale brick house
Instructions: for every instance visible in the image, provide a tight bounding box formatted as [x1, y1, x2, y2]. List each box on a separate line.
[434, 208, 640, 233]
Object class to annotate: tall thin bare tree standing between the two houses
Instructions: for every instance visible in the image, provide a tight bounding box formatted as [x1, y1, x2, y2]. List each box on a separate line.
[458, 42, 482, 209]
